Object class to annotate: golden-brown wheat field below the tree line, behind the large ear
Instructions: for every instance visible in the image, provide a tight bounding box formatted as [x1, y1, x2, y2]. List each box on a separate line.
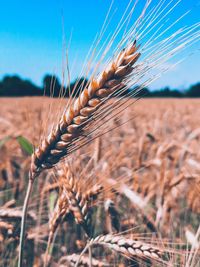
[0, 97, 200, 267]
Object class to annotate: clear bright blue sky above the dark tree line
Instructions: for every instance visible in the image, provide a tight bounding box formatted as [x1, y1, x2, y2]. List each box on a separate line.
[0, 0, 200, 88]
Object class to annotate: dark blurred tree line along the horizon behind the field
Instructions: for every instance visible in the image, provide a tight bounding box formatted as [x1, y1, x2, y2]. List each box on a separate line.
[0, 74, 200, 98]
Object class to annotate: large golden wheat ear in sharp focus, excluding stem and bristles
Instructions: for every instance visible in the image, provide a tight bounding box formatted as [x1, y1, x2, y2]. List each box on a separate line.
[31, 41, 140, 179]
